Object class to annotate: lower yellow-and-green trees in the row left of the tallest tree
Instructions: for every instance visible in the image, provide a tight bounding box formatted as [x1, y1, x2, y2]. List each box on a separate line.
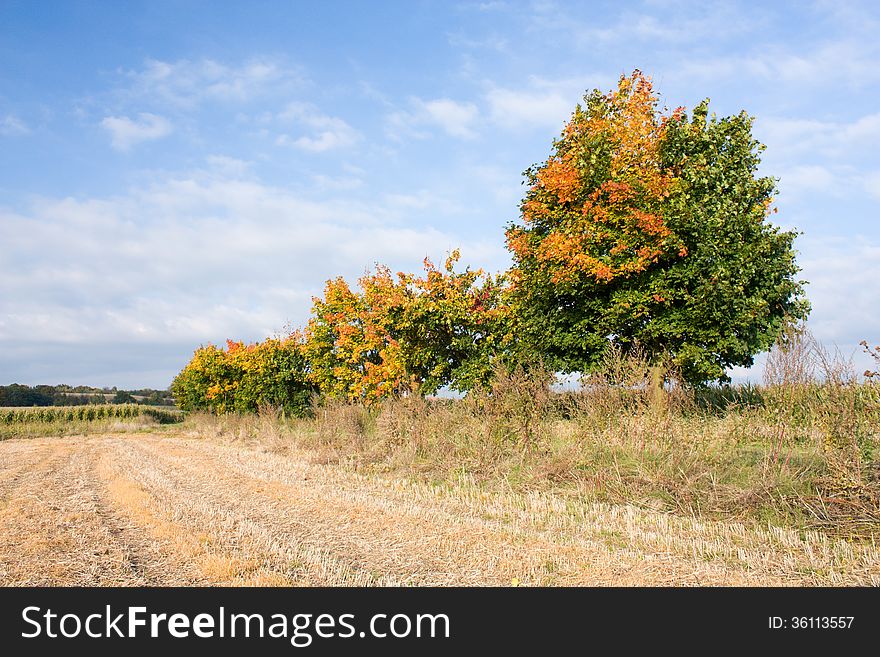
[171, 252, 510, 415]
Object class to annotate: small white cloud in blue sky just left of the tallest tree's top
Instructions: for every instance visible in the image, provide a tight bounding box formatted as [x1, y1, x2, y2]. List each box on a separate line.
[388, 98, 480, 139]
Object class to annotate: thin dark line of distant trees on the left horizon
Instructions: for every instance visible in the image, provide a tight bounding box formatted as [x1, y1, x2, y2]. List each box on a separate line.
[0, 383, 174, 406]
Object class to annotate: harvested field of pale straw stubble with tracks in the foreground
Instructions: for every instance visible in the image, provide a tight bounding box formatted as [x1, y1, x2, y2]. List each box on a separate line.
[0, 434, 880, 586]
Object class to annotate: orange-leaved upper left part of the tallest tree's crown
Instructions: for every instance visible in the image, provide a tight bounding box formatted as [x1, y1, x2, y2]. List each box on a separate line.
[507, 70, 687, 283]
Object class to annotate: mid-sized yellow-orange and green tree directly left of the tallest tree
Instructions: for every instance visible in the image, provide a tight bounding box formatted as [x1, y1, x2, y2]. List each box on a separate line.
[304, 251, 509, 403]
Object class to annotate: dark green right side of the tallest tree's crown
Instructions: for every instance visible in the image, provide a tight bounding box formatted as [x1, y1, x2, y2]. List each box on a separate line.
[656, 103, 809, 381]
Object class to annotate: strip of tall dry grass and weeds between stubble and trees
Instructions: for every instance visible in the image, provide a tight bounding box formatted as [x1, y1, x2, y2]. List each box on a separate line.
[186, 344, 880, 540]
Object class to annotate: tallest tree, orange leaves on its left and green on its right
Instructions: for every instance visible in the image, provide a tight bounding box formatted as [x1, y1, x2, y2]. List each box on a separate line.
[507, 71, 809, 382]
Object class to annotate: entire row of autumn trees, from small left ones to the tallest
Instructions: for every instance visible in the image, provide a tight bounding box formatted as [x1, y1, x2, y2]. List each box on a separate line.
[172, 71, 809, 412]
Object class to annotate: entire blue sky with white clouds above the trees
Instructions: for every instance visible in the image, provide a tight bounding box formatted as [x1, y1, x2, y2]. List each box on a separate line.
[0, 0, 880, 388]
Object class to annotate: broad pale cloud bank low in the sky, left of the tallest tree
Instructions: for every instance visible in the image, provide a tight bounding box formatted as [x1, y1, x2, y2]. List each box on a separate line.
[0, 161, 503, 358]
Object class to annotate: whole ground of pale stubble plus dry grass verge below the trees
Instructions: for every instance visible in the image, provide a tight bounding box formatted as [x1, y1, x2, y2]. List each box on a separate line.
[0, 384, 880, 586]
